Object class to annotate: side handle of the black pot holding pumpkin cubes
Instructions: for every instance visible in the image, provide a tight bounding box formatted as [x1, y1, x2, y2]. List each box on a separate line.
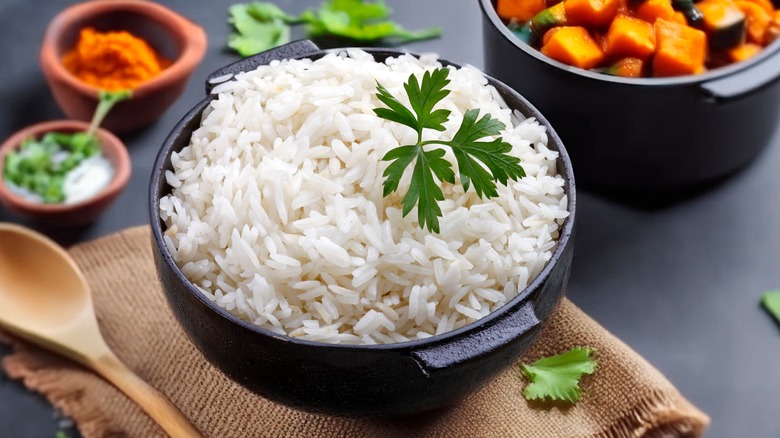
[700, 45, 780, 103]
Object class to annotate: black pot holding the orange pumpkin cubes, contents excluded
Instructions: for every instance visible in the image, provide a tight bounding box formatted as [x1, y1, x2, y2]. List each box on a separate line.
[478, 0, 780, 193]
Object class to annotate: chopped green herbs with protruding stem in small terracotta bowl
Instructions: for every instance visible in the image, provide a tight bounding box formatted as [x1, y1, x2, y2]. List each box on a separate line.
[3, 90, 132, 204]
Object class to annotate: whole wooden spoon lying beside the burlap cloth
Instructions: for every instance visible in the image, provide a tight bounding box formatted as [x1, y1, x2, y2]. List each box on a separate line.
[0, 223, 201, 438]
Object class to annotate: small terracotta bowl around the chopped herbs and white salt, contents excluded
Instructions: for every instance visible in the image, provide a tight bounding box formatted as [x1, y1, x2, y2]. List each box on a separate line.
[0, 120, 131, 226]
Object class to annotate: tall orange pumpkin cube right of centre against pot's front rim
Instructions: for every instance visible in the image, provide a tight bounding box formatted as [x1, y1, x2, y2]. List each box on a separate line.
[653, 19, 707, 76]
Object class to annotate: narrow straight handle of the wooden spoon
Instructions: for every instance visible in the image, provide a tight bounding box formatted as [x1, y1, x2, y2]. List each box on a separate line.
[90, 353, 202, 438]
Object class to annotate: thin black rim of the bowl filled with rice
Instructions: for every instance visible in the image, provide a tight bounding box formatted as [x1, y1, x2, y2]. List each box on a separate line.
[148, 47, 577, 352]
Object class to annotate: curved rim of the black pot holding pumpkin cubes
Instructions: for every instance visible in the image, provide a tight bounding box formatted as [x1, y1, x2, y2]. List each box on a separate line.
[479, 0, 780, 87]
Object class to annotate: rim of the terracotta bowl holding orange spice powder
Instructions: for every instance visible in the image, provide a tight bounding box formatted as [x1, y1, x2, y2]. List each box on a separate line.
[40, 0, 207, 100]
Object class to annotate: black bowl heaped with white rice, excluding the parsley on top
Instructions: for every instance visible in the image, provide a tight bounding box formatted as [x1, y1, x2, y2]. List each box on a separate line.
[150, 41, 575, 415]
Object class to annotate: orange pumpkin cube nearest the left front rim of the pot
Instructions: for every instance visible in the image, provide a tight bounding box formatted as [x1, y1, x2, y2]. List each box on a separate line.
[542, 26, 604, 70]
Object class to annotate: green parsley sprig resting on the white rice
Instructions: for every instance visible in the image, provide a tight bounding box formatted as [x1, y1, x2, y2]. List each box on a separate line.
[374, 68, 525, 233]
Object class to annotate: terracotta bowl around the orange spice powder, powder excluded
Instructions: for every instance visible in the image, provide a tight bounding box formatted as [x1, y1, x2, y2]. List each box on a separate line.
[40, 0, 206, 132]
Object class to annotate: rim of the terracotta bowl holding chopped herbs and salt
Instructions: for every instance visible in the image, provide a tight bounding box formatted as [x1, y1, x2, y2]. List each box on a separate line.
[0, 119, 132, 215]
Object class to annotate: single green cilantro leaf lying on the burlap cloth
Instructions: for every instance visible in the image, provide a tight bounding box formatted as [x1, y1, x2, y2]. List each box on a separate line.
[520, 348, 596, 403]
